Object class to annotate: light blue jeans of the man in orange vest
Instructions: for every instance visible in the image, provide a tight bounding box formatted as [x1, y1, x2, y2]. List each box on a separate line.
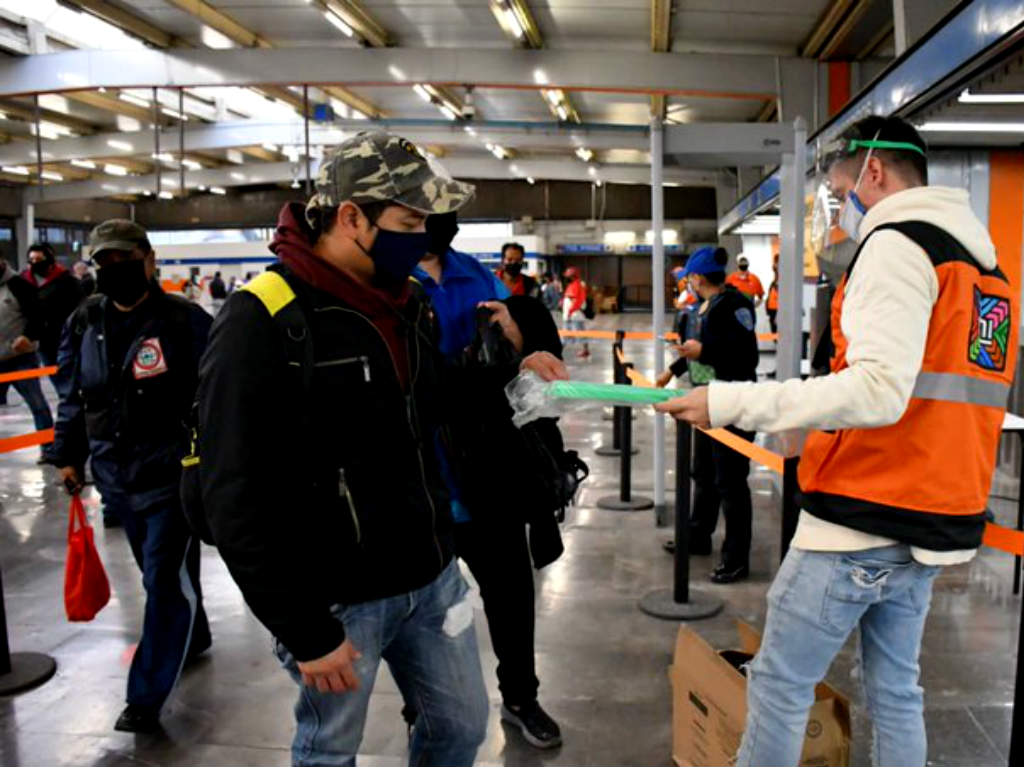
[736, 545, 940, 767]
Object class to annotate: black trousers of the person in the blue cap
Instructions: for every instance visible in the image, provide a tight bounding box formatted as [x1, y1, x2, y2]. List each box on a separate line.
[690, 426, 754, 569]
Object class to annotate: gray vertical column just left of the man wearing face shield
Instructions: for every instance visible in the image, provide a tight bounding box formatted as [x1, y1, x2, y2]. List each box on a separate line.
[775, 119, 807, 381]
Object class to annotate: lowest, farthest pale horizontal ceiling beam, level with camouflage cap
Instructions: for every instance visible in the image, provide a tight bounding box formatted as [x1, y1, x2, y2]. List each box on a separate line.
[25, 156, 717, 203]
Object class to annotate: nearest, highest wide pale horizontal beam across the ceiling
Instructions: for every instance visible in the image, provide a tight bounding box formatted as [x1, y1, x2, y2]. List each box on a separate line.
[0, 47, 776, 100]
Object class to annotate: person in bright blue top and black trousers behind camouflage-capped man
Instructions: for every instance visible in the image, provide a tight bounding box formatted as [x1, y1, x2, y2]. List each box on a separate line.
[414, 215, 568, 749]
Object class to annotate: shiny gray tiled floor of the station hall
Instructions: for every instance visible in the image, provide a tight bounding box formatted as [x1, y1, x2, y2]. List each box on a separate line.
[0, 315, 1020, 767]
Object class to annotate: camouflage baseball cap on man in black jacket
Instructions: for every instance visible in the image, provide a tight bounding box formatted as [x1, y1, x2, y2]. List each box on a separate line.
[306, 131, 474, 223]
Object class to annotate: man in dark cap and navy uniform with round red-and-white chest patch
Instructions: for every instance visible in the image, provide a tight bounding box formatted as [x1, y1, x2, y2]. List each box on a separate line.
[53, 219, 212, 732]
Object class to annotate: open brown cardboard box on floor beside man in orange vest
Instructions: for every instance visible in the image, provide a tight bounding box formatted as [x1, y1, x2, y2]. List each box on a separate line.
[669, 621, 850, 767]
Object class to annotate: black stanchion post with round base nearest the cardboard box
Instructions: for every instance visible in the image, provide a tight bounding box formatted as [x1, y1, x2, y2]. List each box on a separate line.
[640, 421, 725, 621]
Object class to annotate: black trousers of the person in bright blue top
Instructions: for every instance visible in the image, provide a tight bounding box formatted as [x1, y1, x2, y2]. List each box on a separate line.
[455, 520, 540, 706]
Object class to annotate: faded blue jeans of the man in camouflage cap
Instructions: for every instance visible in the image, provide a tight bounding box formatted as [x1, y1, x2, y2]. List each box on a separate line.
[274, 560, 488, 767]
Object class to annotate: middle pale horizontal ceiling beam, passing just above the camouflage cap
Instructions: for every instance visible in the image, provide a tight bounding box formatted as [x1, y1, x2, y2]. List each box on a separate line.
[0, 120, 649, 165]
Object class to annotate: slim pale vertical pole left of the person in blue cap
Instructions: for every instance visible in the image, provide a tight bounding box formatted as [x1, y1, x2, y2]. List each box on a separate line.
[650, 115, 667, 525]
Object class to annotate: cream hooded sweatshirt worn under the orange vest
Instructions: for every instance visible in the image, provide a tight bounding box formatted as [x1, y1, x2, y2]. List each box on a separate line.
[708, 186, 995, 564]
